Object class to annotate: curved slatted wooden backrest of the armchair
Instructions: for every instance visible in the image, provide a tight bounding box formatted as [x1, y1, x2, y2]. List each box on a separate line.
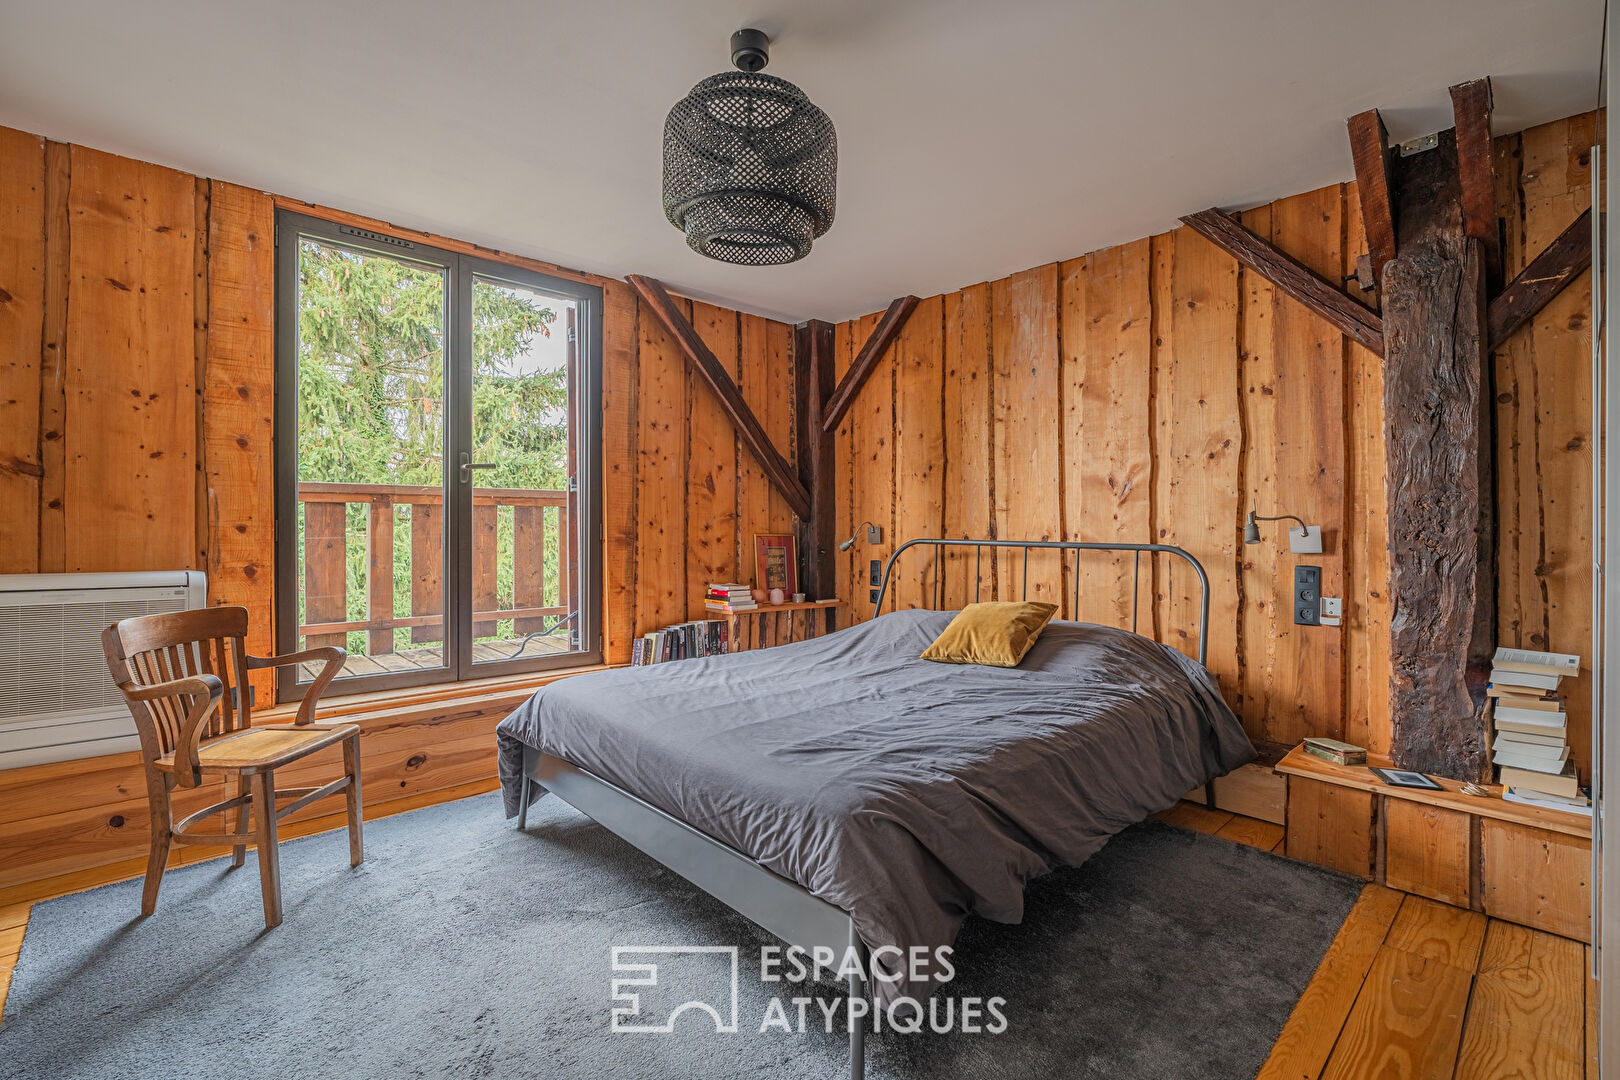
[102, 607, 251, 761]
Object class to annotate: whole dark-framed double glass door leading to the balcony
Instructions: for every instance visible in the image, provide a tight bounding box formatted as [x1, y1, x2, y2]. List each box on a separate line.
[275, 212, 601, 699]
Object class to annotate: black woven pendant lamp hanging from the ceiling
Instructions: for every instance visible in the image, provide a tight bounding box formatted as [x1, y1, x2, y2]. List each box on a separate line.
[664, 29, 838, 266]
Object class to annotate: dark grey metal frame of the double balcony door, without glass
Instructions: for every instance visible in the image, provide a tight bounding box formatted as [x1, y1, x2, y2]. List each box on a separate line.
[274, 209, 604, 701]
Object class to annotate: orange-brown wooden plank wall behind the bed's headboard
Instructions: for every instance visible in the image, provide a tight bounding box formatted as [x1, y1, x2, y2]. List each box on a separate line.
[836, 115, 1594, 769]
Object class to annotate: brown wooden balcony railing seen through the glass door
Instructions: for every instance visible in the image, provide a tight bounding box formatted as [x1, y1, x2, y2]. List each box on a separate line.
[298, 483, 575, 656]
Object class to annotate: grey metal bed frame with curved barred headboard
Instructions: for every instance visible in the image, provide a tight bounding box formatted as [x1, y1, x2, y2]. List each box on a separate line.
[517, 538, 1215, 1080]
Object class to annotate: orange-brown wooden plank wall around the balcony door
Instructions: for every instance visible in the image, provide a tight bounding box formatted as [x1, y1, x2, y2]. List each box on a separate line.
[0, 128, 794, 889]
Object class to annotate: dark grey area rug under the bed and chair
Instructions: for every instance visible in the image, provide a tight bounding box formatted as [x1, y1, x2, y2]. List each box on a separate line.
[0, 795, 1359, 1080]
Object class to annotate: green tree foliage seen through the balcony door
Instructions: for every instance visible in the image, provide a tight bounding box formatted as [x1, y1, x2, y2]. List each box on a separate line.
[298, 238, 569, 653]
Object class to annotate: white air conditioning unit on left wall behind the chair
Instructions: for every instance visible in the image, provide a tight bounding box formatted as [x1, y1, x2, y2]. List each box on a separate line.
[0, 570, 207, 769]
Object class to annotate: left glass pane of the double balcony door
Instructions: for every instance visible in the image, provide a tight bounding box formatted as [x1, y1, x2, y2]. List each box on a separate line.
[288, 235, 450, 682]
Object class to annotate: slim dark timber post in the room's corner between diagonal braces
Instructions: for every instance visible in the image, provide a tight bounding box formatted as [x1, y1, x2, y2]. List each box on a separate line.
[794, 319, 838, 617]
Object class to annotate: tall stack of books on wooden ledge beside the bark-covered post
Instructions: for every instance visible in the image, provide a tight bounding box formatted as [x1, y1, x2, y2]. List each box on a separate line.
[1486, 648, 1592, 814]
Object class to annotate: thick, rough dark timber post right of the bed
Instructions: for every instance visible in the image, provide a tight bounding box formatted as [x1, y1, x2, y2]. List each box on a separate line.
[1382, 131, 1495, 780]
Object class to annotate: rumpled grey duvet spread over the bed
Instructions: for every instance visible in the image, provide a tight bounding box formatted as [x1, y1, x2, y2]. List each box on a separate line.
[497, 610, 1254, 994]
